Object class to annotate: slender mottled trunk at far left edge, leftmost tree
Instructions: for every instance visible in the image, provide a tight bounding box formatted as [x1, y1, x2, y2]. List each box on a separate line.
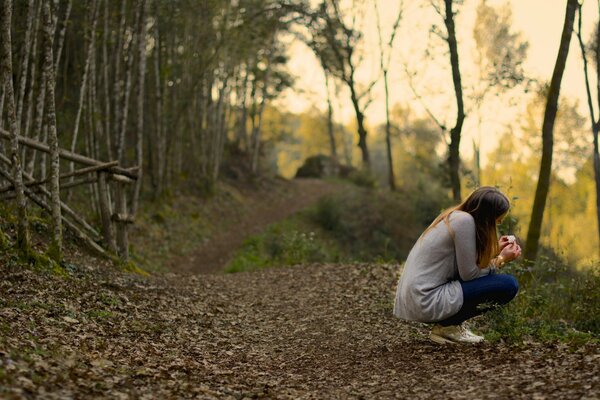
[0, 0, 29, 252]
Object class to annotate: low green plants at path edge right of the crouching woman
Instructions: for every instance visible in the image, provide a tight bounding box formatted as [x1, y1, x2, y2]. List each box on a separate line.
[480, 257, 600, 344]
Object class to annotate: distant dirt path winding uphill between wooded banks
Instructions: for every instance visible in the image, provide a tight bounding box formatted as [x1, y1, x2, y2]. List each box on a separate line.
[169, 179, 342, 274]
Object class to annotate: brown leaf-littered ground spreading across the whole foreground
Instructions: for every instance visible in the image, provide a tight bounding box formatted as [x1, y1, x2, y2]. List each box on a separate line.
[0, 180, 600, 399]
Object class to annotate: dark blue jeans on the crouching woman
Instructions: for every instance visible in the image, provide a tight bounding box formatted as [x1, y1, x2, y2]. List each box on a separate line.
[438, 274, 519, 326]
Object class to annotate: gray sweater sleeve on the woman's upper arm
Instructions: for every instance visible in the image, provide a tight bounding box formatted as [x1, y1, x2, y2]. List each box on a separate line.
[450, 212, 481, 281]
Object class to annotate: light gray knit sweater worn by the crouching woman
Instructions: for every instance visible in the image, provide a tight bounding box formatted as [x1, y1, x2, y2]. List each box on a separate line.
[394, 211, 488, 322]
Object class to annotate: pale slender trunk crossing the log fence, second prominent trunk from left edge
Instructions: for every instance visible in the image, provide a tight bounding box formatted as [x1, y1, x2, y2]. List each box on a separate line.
[43, 0, 62, 263]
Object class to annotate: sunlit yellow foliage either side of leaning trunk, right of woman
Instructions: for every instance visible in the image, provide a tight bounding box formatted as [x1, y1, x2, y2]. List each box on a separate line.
[482, 92, 599, 266]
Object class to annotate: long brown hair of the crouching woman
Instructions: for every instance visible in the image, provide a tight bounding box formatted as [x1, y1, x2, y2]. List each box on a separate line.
[423, 186, 510, 268]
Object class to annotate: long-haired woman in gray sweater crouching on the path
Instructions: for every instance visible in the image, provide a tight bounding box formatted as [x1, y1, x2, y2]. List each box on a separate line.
[394, 187, 521, 343]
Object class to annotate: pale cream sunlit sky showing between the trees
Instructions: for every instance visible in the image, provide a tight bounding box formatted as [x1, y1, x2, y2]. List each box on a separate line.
[281, 0, 598, 167]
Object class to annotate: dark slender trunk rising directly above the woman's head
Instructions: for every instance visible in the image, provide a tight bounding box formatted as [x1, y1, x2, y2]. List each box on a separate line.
[444, 0, 465, 203]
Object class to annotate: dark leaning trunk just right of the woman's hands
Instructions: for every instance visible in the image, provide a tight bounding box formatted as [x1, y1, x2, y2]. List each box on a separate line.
[523, 0, 578, 261]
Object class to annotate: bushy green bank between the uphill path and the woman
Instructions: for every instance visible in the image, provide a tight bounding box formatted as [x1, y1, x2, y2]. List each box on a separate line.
[226, 186, 441, 272]
